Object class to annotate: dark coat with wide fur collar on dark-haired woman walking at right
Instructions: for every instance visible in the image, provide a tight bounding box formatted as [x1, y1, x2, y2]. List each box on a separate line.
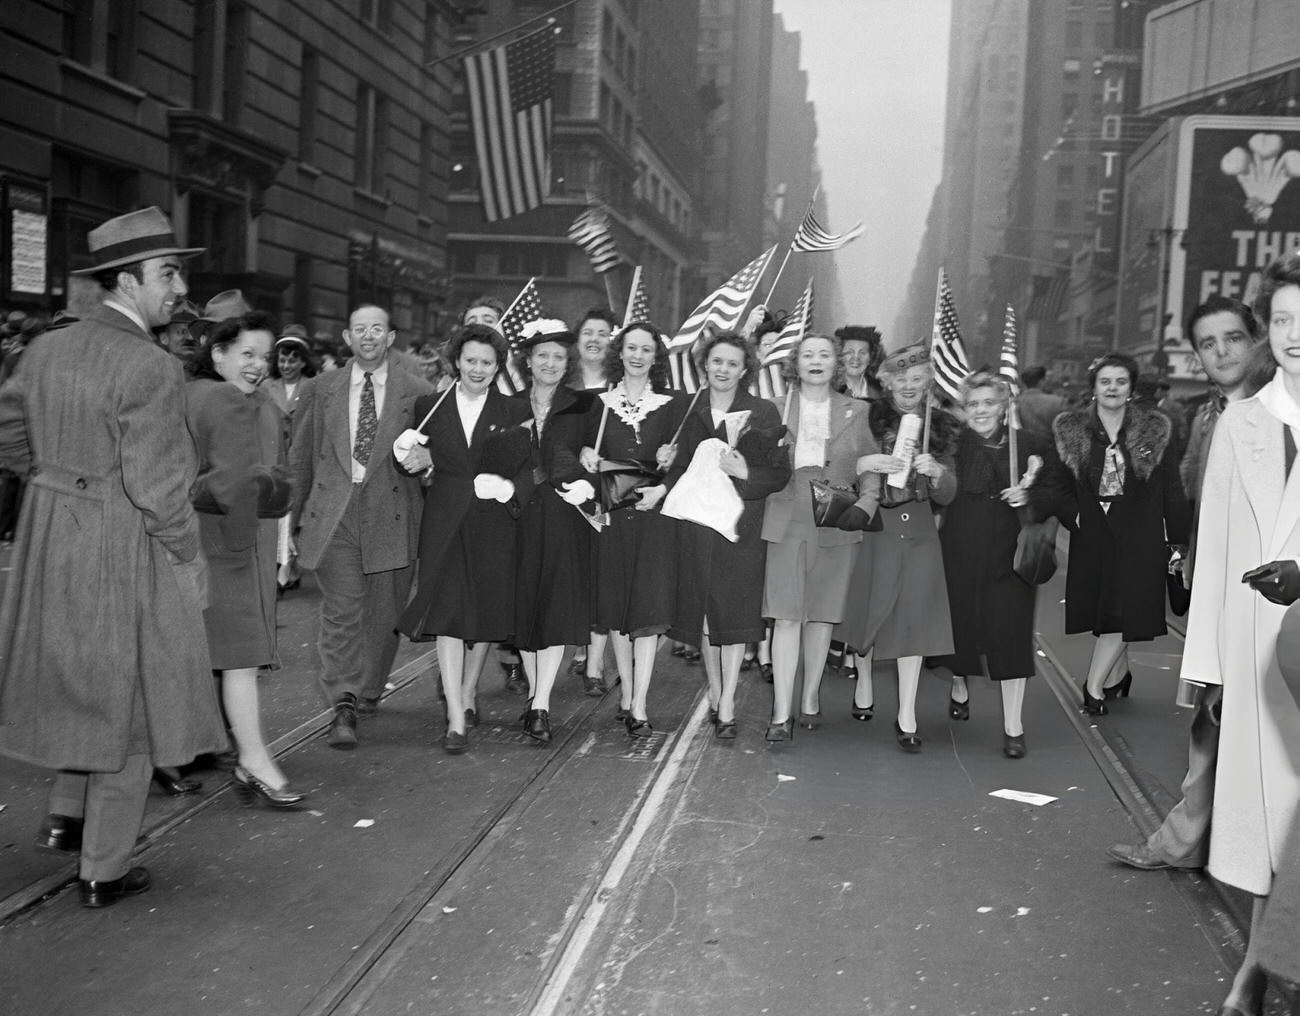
[1052, 405, 1191, 642]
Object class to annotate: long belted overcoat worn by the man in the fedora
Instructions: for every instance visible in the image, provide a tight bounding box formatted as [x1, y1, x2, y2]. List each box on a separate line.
[0, 307, 226, 772]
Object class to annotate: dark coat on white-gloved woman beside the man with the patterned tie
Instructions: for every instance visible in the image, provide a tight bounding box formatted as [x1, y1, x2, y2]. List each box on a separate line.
[398, 388, 533, 642]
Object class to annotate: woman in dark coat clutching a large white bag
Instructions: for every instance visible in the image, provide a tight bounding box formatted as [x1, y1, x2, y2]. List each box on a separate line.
[668, 331, 790, 741]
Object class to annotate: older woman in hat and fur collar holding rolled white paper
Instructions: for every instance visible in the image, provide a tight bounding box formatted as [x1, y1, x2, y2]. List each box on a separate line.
[832, 343, 958, 754]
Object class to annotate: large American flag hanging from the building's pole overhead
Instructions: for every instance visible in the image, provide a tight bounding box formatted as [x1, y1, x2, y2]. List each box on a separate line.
[465, 27, 555, 222]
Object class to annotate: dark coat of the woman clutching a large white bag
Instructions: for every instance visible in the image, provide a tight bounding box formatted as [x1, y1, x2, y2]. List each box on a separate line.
[667, 391, 790, 646]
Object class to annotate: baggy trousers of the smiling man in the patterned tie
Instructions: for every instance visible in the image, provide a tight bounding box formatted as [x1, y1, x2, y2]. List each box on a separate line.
[316, 485, 411, 705]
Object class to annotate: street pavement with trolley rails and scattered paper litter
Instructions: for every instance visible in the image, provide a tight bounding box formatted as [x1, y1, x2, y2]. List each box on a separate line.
[0, 548, 1286, 1016]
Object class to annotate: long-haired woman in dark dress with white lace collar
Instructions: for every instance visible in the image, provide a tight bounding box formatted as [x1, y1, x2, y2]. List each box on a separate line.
[579, 321, 683, 737]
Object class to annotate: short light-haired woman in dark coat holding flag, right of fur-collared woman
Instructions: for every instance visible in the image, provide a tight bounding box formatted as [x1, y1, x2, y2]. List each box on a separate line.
[931, 372, 1058, 759]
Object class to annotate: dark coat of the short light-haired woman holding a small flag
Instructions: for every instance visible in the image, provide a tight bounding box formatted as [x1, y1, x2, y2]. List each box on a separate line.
[931, 429, 1060, 681]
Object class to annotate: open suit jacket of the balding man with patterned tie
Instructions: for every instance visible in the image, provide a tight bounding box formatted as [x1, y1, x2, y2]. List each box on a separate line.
[289, 361, 433, 574]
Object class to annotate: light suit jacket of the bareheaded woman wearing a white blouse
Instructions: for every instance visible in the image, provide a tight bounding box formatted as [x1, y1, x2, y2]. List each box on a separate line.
[763, 388, 880, 547]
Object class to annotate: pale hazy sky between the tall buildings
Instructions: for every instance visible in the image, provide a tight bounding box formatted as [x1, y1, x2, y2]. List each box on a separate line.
[775, 0, 950, 335]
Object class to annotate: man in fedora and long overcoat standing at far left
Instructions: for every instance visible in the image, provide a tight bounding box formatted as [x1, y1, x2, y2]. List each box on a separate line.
[0, 208, 226, 907]
